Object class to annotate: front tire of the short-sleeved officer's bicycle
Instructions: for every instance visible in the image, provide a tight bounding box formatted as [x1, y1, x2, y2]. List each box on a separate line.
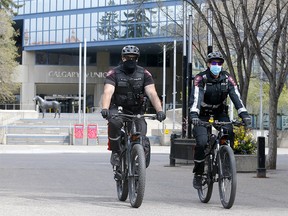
[128, 144, 146, 208]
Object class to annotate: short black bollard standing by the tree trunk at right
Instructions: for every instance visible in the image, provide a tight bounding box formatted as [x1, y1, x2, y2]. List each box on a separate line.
[257, 137, 266, 178]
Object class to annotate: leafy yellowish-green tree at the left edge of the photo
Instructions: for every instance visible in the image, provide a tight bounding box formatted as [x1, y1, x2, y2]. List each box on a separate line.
[0, 9, 18, 102]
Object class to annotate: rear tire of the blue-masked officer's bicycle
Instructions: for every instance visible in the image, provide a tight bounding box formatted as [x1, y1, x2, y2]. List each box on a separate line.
[197, 157, 213, 203]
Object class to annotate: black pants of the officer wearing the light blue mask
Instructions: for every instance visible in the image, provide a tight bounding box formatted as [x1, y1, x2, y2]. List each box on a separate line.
[193, 113, 234, 174]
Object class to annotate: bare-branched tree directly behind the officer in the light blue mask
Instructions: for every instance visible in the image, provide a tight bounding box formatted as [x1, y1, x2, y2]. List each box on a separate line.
[188, 0, 257, 104]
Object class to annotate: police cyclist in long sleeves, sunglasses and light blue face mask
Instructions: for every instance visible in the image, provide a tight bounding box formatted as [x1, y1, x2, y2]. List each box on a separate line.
[189, 52, 251, 189]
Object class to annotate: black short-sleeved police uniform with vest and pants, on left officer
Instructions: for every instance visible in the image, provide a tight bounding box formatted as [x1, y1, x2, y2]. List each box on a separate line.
[104, 64, 154, 151]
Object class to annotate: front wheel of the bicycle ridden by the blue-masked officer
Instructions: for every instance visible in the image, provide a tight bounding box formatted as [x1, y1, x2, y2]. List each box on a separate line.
[218, 146, 237, 209]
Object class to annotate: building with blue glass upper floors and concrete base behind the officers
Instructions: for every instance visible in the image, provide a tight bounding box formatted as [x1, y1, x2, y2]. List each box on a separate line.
[14, 0, 186, 112]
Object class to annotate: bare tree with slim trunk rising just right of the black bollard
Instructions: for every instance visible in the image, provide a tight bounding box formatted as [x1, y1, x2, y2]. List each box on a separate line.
[239, 0, 288, 169]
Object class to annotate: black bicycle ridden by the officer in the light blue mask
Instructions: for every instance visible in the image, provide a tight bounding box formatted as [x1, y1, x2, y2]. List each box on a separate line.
[198, 117, 244, 209]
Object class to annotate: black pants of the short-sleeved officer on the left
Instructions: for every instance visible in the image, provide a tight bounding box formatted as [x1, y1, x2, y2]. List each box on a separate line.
[108, 107, 147, 151]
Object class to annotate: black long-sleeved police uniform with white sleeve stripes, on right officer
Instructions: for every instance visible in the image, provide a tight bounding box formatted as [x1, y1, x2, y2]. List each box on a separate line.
[189, 68, 248, 174]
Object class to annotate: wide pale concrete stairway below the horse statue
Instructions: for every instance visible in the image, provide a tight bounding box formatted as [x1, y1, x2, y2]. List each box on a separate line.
[0, 113, 107, 145]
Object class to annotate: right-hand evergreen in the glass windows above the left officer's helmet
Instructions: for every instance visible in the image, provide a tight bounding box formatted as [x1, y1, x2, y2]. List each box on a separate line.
[121, 0, 156, 38]
